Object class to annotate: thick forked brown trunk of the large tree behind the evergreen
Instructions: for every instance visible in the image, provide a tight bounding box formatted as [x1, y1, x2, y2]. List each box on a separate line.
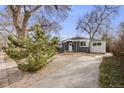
[8, 5, 41, 37]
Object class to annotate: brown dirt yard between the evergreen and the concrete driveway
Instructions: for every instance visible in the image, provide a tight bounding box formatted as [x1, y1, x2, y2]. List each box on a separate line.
[0, 53, 106, 88]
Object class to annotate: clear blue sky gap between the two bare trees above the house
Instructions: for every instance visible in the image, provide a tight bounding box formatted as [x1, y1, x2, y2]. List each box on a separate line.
[59, 5, 92, 39]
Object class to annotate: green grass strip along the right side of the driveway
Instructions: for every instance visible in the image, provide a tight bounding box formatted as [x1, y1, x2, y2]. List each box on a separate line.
[99, 57, 124, 88]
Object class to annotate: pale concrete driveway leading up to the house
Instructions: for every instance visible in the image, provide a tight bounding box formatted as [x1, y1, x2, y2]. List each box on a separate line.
[32, 54, 103, 88]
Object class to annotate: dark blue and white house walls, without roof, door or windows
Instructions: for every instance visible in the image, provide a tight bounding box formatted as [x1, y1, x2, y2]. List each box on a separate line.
[59, 40, 106, 53]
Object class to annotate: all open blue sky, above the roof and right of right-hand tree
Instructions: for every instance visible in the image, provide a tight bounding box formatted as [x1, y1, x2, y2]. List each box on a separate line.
[60, 5, 124, 39]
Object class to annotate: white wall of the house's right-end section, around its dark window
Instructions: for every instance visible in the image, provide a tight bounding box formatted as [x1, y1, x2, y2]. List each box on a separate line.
[90, 41, 106, 53]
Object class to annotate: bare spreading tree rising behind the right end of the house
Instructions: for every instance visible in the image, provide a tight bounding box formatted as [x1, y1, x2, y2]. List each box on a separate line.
[76, 6, 120, 52]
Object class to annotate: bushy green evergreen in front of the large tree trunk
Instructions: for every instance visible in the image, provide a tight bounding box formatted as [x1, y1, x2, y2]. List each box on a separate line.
[6, 25, 58, 72]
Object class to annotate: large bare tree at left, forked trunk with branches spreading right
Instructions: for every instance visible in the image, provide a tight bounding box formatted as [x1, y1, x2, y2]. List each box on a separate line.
[0, 5, 70, 38]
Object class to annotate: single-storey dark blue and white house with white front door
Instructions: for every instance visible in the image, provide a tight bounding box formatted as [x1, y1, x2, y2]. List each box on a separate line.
[58, 37, 106, 53]
